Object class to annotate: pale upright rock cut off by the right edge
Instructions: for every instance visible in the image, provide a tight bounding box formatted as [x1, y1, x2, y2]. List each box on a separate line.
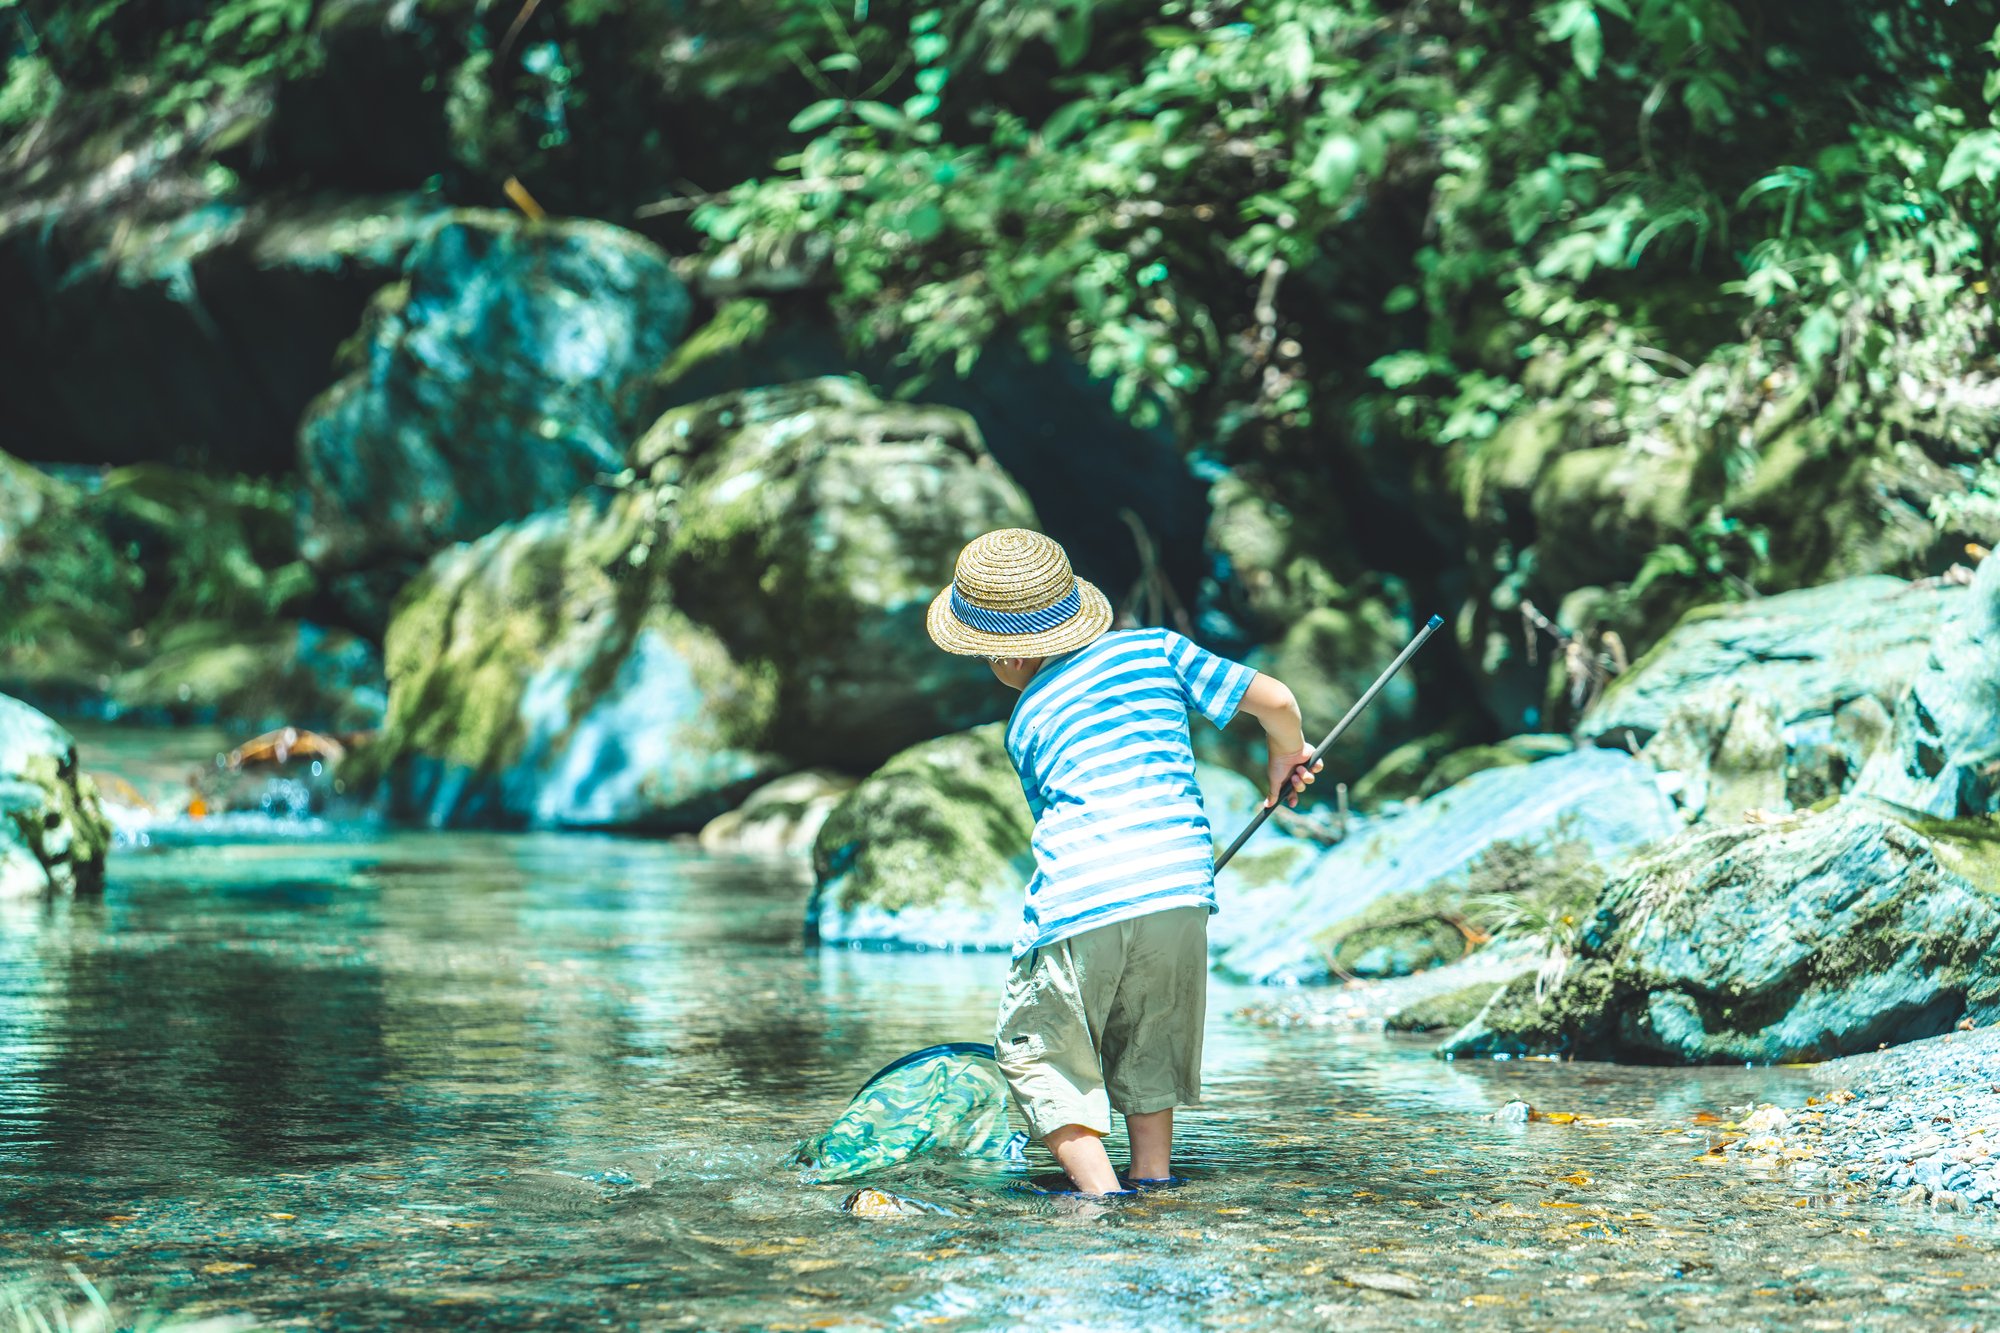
[1858, 556, 2000, 819]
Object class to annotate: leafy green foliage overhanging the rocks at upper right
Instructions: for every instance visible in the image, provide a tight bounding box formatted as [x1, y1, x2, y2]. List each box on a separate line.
[696, 0, 2000, 616]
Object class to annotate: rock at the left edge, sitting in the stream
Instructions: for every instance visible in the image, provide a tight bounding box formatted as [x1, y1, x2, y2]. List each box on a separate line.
[0, 695, 110, 897]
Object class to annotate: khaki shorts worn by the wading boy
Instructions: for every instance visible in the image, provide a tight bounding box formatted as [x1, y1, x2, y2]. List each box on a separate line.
[994, 907, 1208, 1139]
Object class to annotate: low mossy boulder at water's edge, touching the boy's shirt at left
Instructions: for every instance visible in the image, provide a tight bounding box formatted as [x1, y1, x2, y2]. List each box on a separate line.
[806, 723, 1034, 949]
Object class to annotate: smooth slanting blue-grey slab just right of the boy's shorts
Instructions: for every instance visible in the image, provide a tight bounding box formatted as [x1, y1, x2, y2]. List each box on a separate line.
[1210, 749, 1680, 983]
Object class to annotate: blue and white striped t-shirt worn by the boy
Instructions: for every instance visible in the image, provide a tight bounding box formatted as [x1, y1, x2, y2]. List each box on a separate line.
[1006, 628, 1256, 959]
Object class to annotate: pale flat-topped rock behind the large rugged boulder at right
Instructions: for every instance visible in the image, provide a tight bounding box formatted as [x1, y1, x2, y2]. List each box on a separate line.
[1580, 576, 1976, 823]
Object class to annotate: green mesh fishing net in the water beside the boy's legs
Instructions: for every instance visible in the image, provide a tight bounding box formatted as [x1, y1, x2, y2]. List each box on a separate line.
[792, 1041, 1028, 1181]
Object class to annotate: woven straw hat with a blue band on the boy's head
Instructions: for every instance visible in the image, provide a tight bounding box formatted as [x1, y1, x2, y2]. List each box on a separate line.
[926, 528, 1112, 656]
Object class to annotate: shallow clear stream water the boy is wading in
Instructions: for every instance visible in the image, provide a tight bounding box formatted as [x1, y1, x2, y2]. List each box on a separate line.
[0, 740, 2000, 1329]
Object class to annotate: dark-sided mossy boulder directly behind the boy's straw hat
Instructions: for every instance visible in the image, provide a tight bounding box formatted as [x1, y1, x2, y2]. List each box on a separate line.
[634, 378, 1034, 771]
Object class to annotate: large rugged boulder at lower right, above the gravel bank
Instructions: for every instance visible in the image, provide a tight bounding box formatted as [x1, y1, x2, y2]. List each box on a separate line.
[1444, 801, 2000, 1063]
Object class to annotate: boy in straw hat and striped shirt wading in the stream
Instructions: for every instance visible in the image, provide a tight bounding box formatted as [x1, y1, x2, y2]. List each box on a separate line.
[928, 528, 1318, 1195]
